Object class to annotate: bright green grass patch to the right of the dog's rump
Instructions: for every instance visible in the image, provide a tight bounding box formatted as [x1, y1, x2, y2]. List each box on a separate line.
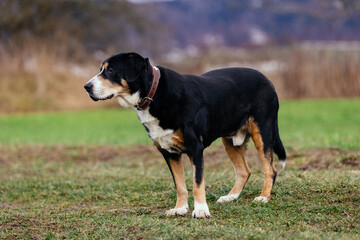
[279, 99, 360, 149]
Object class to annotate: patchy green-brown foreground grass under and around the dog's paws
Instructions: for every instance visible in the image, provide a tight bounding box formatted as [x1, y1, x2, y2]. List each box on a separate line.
[0, 147, 360, 239]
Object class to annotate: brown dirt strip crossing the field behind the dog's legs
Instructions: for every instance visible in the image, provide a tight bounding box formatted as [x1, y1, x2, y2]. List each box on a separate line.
[0, 145, 360, 171]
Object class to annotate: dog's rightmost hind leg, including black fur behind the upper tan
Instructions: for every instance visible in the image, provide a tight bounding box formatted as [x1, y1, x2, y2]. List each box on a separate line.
[250, 121, 276, 203]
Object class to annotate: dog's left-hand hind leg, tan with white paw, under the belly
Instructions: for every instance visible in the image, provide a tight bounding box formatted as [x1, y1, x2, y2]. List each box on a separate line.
[216, 137, 251, 203]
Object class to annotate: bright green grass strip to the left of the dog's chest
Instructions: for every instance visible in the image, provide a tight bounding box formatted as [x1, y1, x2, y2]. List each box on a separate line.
[0, 108, 151, 145]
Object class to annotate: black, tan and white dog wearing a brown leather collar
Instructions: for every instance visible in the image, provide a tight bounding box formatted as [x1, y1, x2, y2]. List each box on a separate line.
[84, 53, 286, 218]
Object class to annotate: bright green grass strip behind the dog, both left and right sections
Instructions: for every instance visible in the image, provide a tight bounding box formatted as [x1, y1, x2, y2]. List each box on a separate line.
[0, 99, 360, 149]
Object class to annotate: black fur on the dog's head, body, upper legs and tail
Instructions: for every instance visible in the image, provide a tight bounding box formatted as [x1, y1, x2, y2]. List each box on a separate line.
[89, 53, 286, 188]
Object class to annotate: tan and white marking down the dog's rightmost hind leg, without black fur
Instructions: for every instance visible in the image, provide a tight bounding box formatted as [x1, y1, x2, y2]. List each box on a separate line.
[250, 120, 274, 202]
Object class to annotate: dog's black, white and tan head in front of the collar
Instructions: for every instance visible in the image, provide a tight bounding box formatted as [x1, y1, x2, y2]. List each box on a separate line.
[84, 53, 152, 108]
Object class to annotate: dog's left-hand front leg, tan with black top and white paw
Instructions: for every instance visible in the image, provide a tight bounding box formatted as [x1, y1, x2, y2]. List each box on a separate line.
[163, 154, 189, 216]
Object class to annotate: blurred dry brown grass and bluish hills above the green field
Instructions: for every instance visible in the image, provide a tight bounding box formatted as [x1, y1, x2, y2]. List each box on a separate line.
[0, 0, 360, 113]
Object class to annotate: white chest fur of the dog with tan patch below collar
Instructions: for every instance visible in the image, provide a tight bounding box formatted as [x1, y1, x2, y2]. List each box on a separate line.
[136, 109, 182, 153]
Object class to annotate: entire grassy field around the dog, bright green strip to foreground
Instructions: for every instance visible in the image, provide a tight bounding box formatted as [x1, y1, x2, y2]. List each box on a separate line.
[0, 99, 360, 239]
